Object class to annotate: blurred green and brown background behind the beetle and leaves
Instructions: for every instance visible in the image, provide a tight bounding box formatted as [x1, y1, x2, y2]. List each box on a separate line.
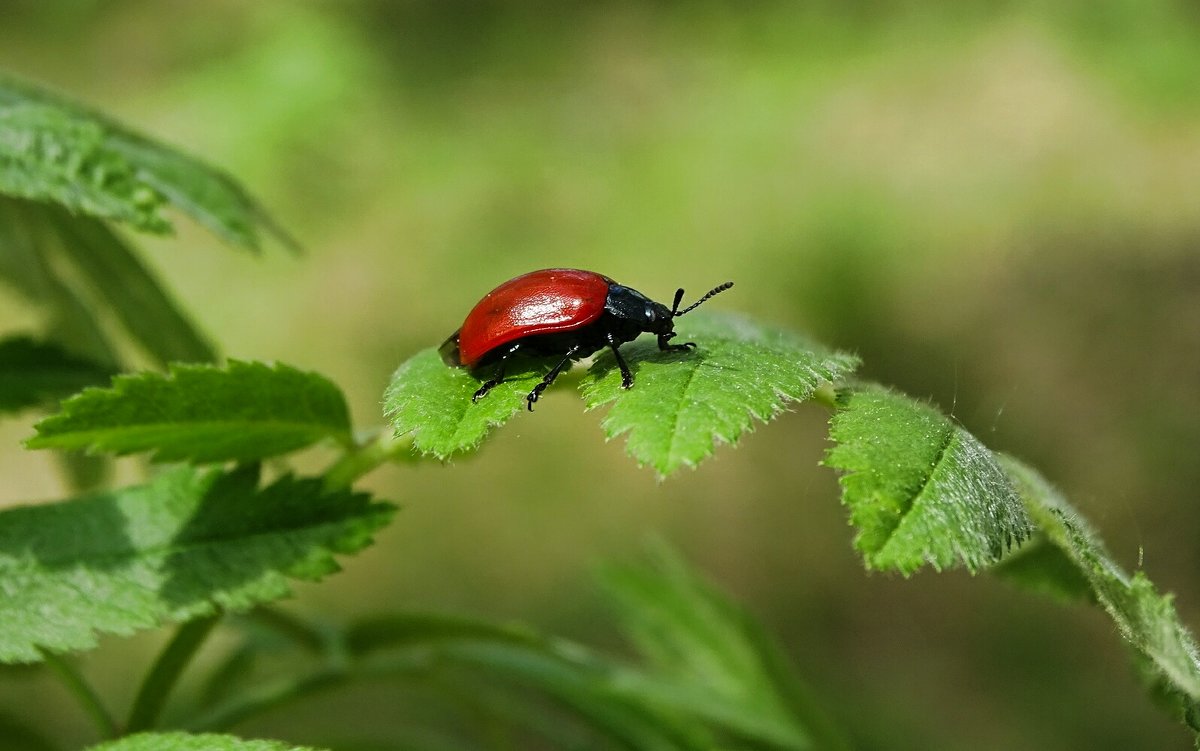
[0, 0, 1200, 750]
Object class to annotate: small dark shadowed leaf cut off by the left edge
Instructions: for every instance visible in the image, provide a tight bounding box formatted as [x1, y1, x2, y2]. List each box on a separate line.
[0, 336, 112, 413]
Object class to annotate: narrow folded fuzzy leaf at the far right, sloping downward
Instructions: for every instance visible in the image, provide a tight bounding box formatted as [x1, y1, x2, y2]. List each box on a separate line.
[1001, 456, 1200, 729]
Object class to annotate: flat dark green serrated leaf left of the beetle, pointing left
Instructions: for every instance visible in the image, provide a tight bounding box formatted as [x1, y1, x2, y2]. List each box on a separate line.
[25, 360, 352, 462]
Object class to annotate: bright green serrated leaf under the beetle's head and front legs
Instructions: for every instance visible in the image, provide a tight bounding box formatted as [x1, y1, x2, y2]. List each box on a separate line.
[581, 312, 858, 475]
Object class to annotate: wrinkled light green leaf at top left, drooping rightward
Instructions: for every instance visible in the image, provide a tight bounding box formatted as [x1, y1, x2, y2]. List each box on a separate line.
[0, 78, 290, 251]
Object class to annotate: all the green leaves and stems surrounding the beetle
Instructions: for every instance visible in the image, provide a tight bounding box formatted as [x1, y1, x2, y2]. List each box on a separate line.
[0, 70, 1200, 751]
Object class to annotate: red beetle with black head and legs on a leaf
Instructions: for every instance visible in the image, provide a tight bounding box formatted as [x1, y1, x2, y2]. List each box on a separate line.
[438, 269, 733, 411]
